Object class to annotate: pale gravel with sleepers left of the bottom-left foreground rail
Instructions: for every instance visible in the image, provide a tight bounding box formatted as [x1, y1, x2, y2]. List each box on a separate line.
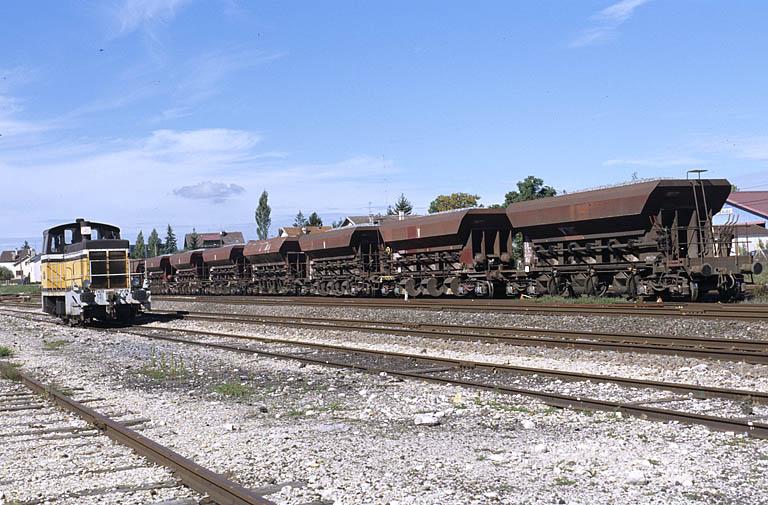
[0, 379, 199, 505]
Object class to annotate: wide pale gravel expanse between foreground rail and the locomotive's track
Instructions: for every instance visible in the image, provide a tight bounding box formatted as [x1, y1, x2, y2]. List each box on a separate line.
[0, 311, 768, 505]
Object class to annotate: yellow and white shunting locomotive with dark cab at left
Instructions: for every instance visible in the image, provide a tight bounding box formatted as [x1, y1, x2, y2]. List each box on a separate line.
[40, 219, 151, 321]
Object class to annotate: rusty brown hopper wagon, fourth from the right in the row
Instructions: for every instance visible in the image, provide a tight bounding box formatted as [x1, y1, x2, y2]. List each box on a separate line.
[243, 237, 307, 295]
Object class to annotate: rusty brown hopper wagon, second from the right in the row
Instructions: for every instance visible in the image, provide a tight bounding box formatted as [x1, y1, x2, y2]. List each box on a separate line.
[381, 209, 512, 296]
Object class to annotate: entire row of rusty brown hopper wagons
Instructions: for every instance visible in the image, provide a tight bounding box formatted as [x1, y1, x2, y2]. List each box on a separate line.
[137, 179, 763, 301]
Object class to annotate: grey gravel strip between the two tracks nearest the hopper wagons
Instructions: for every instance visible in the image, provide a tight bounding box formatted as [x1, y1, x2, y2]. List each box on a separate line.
[152, 301, 768, 340]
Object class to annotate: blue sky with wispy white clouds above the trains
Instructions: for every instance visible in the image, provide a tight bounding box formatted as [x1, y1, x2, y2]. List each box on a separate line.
[0, 0, 768, 248]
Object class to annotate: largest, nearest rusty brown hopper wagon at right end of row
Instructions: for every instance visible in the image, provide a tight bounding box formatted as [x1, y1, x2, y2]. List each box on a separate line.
[507, 179, 751, 299]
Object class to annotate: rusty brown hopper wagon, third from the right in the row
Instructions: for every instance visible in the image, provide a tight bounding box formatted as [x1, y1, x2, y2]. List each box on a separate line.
[299, 225, 382, 296]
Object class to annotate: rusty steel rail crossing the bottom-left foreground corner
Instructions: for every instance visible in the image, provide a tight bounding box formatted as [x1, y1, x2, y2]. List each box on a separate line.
[9, 364, 274, 505]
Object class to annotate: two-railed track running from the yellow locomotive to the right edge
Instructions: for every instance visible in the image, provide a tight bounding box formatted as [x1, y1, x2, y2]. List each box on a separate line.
[1, 308, 768, 438]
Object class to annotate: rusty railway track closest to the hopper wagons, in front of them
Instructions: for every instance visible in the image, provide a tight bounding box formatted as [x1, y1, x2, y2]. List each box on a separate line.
[153, 295, 768, 321]
